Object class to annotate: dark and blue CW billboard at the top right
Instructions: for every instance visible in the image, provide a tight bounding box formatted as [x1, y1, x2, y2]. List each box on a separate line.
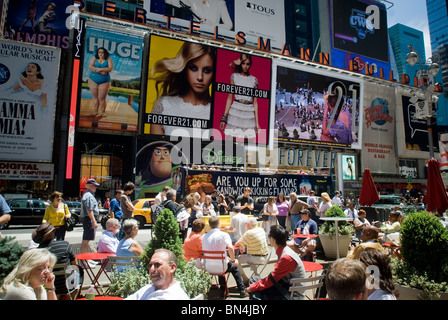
[329, 0, 391, 76]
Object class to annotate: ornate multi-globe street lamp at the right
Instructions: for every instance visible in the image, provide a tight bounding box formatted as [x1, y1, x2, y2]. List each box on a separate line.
[406, 45, 440, 159]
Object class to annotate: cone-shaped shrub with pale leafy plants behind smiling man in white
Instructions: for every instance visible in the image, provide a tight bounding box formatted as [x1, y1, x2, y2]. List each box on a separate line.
[110, 209, 212, 298]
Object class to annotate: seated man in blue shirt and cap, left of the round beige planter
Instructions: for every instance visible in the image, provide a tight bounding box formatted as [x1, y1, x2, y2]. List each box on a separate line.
[288, 209, 318, 261]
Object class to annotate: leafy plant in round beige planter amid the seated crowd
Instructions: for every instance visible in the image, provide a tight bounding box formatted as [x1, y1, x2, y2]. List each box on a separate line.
[319, 206, 355, 258]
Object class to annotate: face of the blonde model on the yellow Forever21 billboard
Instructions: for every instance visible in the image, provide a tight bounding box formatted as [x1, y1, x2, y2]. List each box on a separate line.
[187, 54, 213, 93]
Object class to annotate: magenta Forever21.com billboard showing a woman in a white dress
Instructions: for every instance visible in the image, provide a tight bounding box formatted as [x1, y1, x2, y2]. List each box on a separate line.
[213, 49, 272, 144]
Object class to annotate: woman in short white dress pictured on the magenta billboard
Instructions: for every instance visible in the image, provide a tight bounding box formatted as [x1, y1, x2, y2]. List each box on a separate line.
[220, 53, 261, 138]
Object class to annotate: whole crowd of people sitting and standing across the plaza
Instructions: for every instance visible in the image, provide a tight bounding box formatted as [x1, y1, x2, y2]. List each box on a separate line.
[0, 179, 446, 300]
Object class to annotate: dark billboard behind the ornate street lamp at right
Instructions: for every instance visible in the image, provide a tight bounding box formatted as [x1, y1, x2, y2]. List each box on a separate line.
[397, 95, 439, 159]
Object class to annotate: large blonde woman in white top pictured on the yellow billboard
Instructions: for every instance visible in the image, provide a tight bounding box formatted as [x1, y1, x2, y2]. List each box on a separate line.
[149, 42, 215, 135]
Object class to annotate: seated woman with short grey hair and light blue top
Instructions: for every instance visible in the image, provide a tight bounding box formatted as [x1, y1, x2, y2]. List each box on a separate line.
[116, 219, 143, 273]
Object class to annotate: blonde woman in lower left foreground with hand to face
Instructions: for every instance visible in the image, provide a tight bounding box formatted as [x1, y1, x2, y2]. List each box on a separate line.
[0, 249, 57, 300]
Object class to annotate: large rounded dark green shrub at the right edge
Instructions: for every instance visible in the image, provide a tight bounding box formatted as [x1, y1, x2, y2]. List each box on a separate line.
[392, 211, 448, 300]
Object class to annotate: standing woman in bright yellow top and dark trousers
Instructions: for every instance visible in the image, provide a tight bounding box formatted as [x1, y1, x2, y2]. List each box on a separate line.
[42, 191, 71, 240]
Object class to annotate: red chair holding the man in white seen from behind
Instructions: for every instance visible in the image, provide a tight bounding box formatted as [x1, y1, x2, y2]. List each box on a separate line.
[199, 250, 230, 298]
